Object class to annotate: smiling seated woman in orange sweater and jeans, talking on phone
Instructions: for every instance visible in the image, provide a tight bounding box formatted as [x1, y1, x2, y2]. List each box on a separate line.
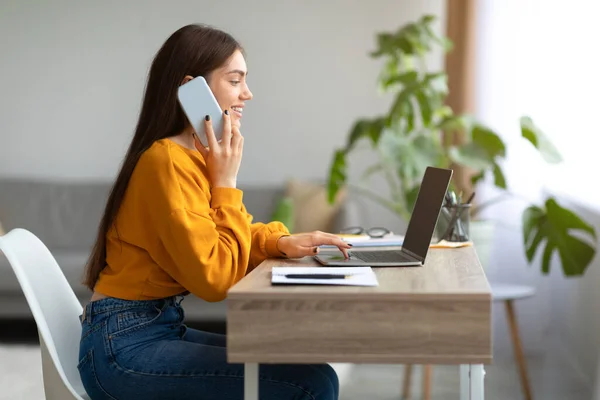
[78, 25, 348, 400]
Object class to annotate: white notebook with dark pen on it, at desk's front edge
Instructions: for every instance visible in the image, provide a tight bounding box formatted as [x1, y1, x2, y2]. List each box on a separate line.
[271, 267, 379, 286]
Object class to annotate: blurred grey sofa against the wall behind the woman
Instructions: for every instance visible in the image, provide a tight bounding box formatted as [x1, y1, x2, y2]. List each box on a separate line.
[0, 179, 356, 321]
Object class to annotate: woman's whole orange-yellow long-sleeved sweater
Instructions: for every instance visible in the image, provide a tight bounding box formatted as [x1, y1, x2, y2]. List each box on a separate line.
[95, 139, 289, 301]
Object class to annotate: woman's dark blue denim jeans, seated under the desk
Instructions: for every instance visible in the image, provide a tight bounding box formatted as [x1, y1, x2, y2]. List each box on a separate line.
[78, 297, 339, 400]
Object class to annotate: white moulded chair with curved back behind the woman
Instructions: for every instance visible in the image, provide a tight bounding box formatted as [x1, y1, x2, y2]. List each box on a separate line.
[0, 229, 89, 400]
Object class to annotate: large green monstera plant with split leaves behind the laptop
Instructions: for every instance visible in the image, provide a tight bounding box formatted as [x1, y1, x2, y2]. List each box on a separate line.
[328, 15, 596, 276]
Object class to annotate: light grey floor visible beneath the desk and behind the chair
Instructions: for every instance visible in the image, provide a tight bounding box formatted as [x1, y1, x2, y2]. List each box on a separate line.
[0, 324, 592, 400]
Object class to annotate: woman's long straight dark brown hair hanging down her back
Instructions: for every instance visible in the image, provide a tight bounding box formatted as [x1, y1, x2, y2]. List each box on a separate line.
[83, 25, 243, 291]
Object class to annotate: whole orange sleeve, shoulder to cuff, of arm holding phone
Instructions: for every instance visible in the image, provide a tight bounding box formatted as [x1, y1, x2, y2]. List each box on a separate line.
[140, 148, 252, 302]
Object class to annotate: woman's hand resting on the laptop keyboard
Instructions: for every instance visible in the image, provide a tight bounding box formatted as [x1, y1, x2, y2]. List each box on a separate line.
[277, 231, 352, 258]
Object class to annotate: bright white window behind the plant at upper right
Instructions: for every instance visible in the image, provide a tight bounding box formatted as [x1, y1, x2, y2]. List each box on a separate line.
[476, 0, 600, 211]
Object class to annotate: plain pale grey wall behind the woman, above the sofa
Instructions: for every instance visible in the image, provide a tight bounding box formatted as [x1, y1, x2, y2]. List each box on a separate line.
[0, 0, 445, 230]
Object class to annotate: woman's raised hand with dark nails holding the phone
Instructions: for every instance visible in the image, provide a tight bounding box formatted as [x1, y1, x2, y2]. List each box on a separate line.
[194, 110, 244, 188]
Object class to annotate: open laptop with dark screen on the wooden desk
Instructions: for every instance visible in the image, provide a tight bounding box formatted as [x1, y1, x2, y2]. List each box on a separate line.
[314, 167, 453, 267]
